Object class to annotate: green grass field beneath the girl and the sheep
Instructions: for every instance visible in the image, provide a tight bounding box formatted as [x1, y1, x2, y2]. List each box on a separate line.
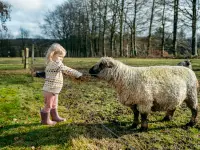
[0, 58, 200, 150]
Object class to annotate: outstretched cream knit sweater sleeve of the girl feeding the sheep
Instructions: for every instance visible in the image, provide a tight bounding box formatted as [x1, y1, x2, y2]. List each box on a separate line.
[58, 61, 82, 78]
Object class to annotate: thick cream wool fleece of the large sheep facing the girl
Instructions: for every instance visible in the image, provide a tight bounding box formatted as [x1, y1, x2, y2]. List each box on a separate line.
[99, 58, 197, 113]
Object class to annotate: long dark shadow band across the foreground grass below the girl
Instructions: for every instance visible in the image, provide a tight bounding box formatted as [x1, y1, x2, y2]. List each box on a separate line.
[0, 122, 199, 149]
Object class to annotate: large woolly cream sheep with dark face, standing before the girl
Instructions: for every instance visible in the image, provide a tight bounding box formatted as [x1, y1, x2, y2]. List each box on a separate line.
[89, 57, 198, 131]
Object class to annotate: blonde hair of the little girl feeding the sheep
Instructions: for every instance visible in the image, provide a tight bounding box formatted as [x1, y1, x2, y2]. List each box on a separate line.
[46, 43, 66, 63]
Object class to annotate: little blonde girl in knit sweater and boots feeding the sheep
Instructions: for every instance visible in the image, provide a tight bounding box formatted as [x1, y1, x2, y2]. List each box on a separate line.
[40, 43, 82, 125]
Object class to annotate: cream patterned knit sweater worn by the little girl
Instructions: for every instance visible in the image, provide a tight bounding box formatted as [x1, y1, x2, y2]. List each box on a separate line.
[43, 61, 82, 94]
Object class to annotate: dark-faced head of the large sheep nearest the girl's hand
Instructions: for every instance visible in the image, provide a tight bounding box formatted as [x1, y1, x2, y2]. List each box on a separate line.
[89, 59, 113, 77]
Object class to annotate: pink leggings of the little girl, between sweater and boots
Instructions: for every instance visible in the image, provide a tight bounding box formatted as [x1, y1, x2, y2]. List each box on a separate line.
[42, 92, 58, 112]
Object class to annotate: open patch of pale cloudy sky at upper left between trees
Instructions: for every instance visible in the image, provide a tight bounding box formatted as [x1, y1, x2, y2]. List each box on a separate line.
[4, 0, 66, 37]
